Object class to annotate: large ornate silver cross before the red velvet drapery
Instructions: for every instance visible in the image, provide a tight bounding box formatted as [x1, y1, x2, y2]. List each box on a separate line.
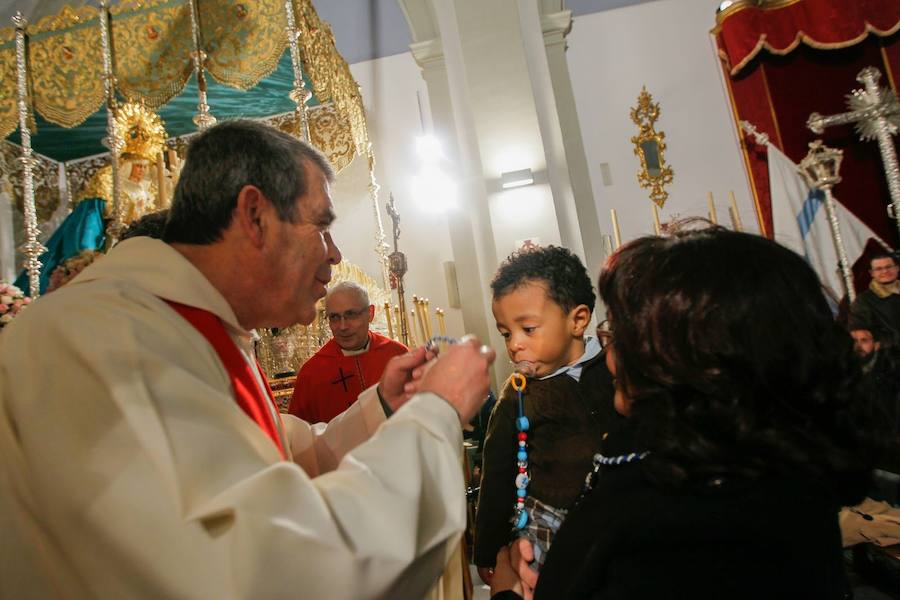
[806, 67, 900, 239]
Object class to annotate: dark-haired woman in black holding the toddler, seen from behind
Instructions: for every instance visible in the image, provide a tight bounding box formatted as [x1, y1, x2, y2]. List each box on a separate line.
[492, 228, 881, 599]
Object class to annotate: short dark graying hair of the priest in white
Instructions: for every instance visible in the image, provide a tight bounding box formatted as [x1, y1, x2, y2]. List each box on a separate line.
[163, 119, 334, 244]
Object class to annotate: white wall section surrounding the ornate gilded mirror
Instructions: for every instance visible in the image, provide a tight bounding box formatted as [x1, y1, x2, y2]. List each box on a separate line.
[567, 0, 759, 242]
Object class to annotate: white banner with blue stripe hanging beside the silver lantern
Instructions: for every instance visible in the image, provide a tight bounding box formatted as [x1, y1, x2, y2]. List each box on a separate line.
[768, 144, 884, 301]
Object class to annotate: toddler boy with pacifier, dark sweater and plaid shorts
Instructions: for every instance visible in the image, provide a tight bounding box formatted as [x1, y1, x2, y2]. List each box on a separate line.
[474, 246, 620, 581]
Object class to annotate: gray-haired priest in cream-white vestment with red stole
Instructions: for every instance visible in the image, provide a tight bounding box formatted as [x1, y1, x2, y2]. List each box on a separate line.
[0, 121, 493, 599]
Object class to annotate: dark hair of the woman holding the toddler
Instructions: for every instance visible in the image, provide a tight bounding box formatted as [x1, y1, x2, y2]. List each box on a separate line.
[598, 227, 884, 503]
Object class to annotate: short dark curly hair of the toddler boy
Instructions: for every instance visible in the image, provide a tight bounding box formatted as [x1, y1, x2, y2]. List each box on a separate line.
[491, 246, 597, 313]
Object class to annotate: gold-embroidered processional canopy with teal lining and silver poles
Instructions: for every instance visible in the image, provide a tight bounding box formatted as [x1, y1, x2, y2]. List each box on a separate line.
[0, 0, 396, 372]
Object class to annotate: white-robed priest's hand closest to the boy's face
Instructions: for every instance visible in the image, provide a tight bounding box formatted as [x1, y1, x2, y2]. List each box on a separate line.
[418, 336, 496, 425]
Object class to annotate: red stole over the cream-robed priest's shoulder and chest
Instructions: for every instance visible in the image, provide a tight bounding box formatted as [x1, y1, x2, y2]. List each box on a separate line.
[165, 300, 287, 458]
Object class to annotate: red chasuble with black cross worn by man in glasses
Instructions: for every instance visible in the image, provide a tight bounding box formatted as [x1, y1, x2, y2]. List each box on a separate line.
[290, 331, 406, 423]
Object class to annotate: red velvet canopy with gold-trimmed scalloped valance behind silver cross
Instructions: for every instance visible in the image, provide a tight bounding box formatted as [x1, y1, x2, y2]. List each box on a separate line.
[713, 0, 900, 253]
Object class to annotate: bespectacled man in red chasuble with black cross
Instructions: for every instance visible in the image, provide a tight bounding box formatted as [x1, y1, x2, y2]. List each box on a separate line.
[290, 281, 407, 423]
